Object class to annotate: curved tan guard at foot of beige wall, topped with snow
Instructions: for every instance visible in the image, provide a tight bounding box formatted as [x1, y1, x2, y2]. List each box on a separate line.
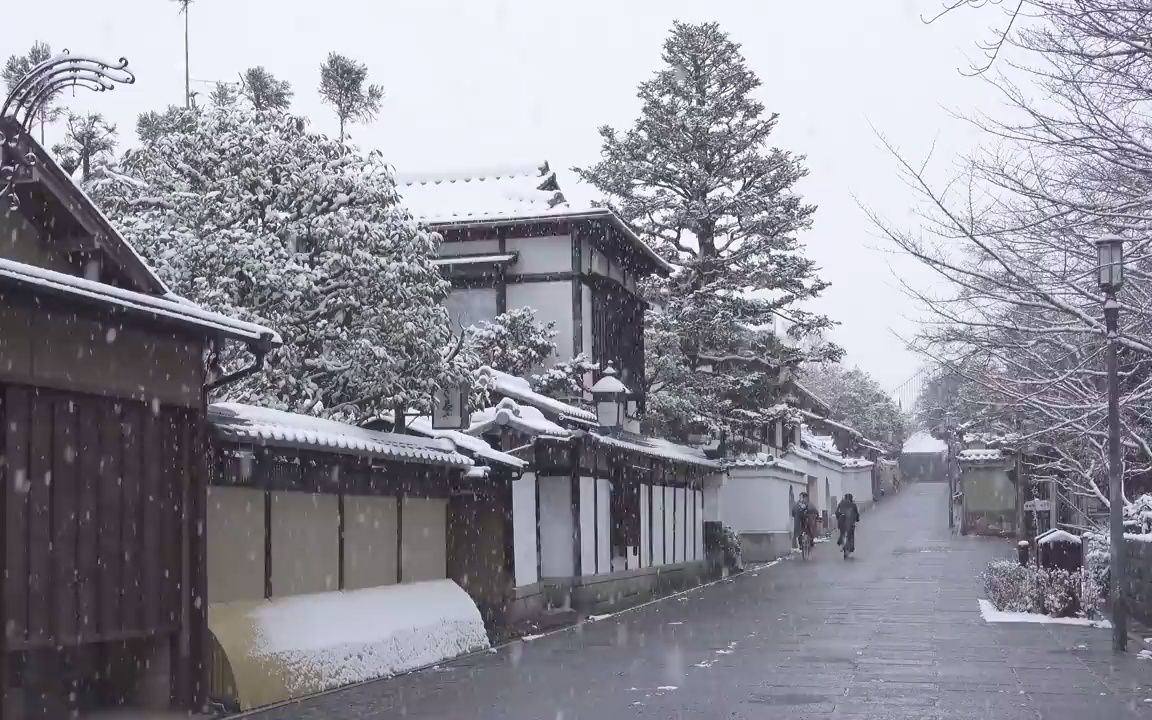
[209, 579, 488, 710]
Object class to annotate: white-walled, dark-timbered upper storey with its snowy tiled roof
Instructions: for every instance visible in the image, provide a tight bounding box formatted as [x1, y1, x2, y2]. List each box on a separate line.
[396, 162, 669, 400]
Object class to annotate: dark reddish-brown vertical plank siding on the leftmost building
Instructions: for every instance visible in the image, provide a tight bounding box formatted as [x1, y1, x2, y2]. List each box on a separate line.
[0, 385, 194, 652]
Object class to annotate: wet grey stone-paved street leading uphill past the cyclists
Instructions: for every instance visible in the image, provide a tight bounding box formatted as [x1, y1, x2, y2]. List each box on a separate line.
[238, 485, 1152, 720]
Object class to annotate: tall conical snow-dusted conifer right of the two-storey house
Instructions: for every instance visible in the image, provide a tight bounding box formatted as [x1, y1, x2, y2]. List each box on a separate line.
[576, 22, 840, 435]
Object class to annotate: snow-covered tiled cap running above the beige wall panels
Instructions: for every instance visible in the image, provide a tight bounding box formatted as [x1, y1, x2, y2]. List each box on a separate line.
[209, 402, 472, 468]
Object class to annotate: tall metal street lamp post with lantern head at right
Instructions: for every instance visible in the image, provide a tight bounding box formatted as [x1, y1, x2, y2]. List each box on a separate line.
[1096, 235, 1128, 652]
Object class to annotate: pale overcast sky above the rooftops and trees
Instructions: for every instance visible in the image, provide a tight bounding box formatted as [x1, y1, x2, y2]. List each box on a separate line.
[9, 0, 1013, 389]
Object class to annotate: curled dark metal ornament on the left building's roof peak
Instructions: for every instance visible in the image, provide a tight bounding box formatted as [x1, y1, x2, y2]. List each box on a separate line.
[0, 50, 136, 209]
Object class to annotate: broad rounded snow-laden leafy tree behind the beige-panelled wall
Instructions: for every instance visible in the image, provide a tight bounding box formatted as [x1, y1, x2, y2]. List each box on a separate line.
[86, 103, 463, 423]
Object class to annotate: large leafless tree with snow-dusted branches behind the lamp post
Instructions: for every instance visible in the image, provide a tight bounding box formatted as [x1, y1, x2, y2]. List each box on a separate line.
[873, 0, 1152, 518]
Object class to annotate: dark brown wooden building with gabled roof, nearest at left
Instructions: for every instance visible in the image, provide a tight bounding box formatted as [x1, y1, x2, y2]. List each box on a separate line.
[0, 116, 279, 720]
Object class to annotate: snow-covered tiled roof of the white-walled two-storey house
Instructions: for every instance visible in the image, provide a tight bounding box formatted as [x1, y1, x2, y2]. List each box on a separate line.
[396, 162, 672, 272]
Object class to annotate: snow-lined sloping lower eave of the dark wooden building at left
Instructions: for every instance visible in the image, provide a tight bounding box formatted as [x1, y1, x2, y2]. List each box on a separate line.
[0, 258, 282, 344]
